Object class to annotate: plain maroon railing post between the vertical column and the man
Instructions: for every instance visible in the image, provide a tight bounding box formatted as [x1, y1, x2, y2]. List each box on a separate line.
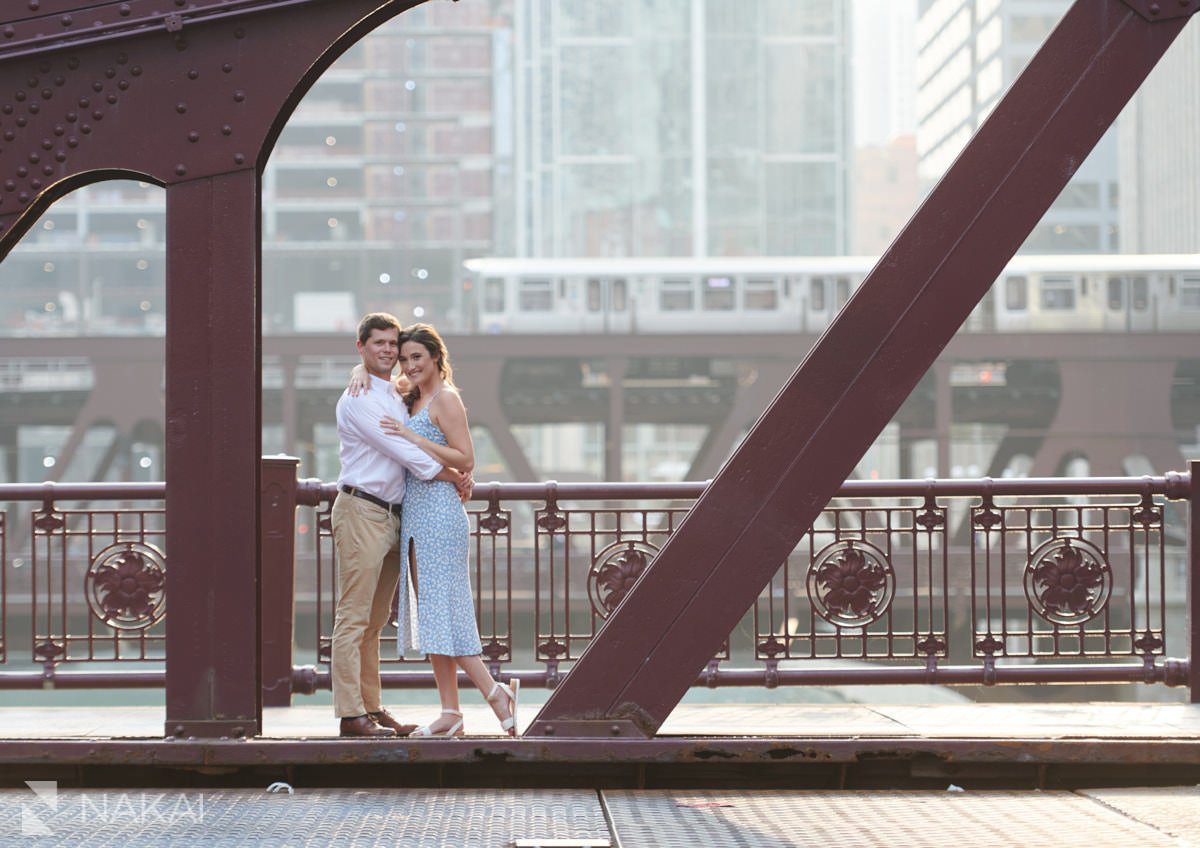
[260, 455, 300, 706]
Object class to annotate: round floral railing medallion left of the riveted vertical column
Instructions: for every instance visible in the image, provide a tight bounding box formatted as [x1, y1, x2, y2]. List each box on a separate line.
[85, 542, 167, 630]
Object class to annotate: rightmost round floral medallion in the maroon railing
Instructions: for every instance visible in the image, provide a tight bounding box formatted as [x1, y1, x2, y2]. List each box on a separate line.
[1025, 539, 1112, 626]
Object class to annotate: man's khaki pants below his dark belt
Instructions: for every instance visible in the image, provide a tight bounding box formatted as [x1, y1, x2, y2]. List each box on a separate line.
[330, 492, 400, 718]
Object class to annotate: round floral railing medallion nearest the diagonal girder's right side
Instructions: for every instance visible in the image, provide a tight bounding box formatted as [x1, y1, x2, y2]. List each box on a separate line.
[808, 539, 895, 627]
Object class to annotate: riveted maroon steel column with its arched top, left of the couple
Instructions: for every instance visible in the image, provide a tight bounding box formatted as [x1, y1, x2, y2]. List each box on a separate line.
[0, 0, 432, 736]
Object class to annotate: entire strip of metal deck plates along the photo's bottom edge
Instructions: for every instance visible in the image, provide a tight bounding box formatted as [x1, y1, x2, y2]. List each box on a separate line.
[0, 782, 1200, 848]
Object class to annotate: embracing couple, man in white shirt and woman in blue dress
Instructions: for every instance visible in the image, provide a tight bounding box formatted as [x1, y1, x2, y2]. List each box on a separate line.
[331, 312, 518, 738]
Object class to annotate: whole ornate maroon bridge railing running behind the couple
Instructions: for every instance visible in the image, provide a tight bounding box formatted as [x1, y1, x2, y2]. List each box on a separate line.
[0, 457, 1200, 705]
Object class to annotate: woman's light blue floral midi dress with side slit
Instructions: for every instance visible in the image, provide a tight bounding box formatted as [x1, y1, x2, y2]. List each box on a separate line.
[397, 398, 482, 656]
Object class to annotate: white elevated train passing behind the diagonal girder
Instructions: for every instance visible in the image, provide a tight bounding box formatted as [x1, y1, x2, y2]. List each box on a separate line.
[464, 254, 1200, 333]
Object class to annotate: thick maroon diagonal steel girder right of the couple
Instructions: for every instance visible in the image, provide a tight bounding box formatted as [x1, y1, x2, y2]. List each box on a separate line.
[526, 0, 1200, 736]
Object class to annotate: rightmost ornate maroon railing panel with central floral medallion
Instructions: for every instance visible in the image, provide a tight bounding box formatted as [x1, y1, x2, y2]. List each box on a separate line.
[971, 495, 1166, 658]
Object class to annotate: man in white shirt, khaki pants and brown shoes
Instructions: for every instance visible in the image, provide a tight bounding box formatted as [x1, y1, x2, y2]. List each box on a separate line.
[331, 312, 468, 738]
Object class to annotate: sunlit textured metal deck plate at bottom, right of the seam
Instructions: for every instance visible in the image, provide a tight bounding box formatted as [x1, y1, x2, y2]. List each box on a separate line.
[604, 790, 1180, 848]
